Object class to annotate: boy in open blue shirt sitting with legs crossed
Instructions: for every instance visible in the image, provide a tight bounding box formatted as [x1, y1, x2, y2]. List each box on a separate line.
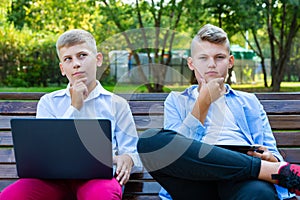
[138, 24, 300, 200]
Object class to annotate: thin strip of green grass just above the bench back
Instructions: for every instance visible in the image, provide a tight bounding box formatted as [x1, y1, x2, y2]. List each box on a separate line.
[0, 82, 300, 93]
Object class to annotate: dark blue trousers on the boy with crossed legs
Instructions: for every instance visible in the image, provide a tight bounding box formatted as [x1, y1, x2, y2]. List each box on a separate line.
[137, 129, 278, 200]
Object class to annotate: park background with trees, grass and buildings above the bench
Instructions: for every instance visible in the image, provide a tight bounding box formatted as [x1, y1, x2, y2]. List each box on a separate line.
[0, 0, 300, 92]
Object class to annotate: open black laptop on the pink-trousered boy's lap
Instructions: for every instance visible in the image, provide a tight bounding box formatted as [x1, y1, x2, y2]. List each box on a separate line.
[11, 118, 113, 179]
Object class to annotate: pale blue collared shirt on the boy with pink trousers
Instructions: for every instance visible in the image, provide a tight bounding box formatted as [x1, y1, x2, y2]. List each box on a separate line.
[36, 81, 142, 172]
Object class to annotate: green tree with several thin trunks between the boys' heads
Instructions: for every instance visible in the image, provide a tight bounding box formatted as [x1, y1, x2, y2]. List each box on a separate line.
[101, 0, 186, 92]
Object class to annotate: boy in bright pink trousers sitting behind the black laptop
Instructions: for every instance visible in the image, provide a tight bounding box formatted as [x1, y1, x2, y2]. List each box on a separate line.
[0, 29, 142, 200]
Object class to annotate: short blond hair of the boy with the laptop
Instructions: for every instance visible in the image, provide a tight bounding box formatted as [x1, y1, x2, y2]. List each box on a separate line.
[56, 29, 97, 56]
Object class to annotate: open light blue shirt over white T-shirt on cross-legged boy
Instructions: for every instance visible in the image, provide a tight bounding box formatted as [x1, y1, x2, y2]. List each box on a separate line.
[160, 85, 294, 200]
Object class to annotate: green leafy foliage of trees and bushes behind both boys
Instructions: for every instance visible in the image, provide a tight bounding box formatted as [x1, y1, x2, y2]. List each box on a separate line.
[0, 0, 300, 90]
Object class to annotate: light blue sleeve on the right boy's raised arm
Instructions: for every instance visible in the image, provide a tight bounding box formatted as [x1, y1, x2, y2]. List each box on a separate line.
[164, 92, 205, 141]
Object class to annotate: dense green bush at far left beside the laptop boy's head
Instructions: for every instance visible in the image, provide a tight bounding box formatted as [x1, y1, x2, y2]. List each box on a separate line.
[0, 25, 66, 87]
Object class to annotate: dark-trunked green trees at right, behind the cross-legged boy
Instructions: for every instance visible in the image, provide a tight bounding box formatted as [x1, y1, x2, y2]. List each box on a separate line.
[197, 0, 300, 91]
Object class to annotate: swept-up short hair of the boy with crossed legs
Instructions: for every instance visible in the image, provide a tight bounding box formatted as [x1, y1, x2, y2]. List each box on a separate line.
[191, 24, 230, 53]
